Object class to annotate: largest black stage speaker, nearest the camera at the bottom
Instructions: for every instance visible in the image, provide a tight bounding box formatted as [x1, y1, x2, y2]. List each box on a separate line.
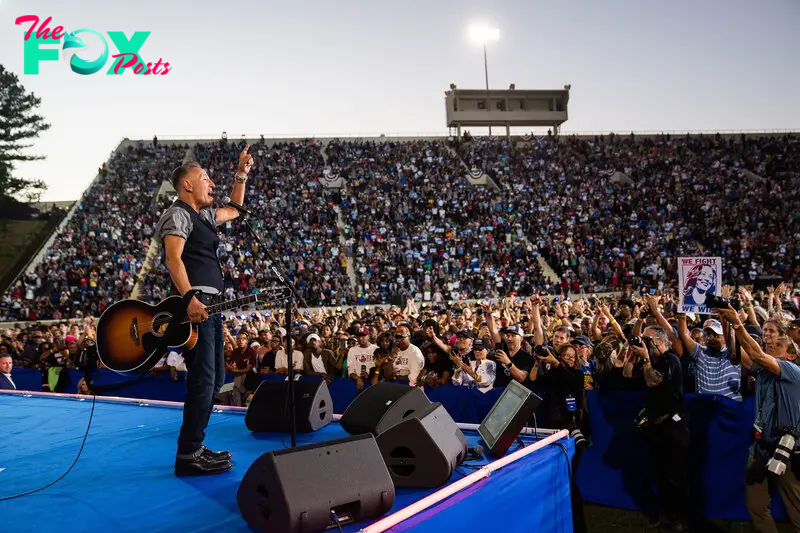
[241, 434, 394, 533]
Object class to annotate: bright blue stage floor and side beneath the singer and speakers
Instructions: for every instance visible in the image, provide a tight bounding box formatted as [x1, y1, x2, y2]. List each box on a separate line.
[0, 394, 572, 533]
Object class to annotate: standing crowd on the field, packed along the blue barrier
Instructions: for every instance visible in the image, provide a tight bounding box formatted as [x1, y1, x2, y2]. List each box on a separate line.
[0, 284, 800, 531]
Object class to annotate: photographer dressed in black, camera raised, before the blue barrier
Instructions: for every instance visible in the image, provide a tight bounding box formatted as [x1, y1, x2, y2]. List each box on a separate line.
[630, 326, 689, 531]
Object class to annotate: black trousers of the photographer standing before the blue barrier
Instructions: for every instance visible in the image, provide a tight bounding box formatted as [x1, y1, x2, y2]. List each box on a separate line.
[642, 418, 689, 520]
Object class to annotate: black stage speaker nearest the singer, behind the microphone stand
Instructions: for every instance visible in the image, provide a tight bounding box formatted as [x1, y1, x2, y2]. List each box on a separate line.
[244, 380, 333, 433]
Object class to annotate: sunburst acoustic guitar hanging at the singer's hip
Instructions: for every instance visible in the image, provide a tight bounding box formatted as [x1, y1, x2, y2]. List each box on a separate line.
[96, 286, 291, 373]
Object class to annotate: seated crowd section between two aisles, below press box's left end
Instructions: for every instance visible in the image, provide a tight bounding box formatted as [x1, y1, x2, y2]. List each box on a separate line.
[327, 140, 547, 304]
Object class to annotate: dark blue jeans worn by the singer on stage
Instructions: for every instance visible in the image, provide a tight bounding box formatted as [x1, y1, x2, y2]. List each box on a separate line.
[178, 306, 225, 454]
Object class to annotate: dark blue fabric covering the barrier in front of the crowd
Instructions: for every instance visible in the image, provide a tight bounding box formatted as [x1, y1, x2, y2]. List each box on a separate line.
[13, 369, 785, 520]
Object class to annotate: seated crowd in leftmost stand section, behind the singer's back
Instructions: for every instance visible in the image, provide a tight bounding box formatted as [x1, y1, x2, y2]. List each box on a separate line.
[0, 143, 188, 321]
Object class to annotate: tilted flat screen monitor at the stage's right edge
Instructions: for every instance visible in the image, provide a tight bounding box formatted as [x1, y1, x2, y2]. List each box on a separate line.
[478, 379, 542, 457]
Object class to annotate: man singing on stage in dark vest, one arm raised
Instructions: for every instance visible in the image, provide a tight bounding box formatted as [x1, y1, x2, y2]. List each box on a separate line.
[156, 146, 253, 476]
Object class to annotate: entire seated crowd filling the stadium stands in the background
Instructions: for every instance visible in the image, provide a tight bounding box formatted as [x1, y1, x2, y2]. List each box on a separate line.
[0, 134, 800, 320]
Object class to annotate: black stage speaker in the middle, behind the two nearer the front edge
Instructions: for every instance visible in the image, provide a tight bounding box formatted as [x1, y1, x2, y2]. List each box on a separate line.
[339, 381, 431, 436]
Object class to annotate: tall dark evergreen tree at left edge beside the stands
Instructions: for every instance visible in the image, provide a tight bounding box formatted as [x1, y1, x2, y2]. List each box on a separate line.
[0, 65, 50, 205]
